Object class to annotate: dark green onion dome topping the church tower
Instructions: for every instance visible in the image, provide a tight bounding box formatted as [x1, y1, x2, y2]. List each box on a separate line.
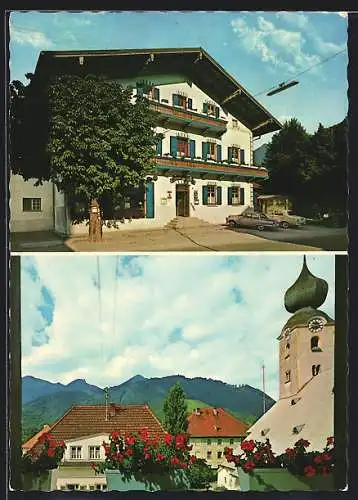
[285, 256, 328, 313]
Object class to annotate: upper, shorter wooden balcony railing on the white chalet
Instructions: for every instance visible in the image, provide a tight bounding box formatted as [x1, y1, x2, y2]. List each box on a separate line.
[150, 101, 228, 134]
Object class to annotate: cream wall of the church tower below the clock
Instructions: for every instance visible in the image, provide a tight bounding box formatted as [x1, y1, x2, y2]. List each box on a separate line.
[279, 322, 334, 398]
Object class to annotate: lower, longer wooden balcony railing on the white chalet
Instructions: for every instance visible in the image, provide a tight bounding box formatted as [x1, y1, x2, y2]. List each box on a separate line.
[155, 155, 268, 179]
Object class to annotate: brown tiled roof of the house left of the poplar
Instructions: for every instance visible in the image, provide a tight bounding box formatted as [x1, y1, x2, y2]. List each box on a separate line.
[34, 404, 164, 441]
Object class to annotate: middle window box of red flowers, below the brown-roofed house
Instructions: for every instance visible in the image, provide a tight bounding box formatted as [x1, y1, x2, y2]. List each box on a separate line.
[93, 428, 196, 491]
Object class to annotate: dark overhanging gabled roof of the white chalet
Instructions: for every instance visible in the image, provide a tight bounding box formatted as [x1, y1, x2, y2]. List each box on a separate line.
[32, 47, 282, 136]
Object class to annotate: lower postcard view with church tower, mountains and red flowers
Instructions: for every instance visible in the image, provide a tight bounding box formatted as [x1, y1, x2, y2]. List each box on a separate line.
[9, 253, 347, 492]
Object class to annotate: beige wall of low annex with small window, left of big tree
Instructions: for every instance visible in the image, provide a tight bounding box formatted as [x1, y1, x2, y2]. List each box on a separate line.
[9, 175, 54, 232]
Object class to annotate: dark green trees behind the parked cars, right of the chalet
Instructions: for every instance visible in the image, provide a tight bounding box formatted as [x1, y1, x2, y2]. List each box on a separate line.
[264, 118, 347, 217]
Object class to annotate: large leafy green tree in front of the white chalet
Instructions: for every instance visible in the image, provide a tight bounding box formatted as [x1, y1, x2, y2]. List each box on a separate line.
[12, 75, 158, 239]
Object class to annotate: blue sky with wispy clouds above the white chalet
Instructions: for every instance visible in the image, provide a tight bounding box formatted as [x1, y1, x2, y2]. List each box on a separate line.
[10, 11, 348, 147]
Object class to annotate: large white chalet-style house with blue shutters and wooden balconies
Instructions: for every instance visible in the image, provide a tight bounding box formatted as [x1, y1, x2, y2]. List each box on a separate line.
[10, 48, 281, 235]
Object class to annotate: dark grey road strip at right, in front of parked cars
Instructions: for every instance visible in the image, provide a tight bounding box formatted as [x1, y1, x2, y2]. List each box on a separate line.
[230, 225, 348, 251]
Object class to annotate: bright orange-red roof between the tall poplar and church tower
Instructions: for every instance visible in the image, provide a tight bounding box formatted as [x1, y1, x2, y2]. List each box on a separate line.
[188, 408, 249, 437]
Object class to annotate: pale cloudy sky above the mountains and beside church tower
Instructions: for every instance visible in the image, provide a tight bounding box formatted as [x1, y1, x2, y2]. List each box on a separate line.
[21, 254, 334, 399]
